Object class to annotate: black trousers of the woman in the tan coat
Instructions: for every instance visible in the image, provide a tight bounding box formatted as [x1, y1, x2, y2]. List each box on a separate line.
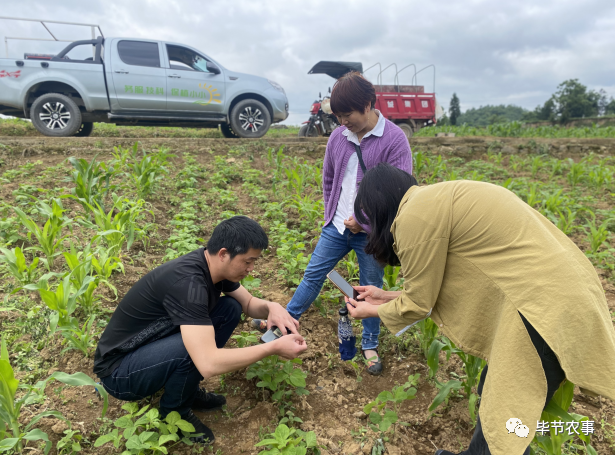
[459, 313, 566, 455]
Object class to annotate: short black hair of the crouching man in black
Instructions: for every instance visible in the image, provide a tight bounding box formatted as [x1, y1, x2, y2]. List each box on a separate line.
[207, 216, 269, 259]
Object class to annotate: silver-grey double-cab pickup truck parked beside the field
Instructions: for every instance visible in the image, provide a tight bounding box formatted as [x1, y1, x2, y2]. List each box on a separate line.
[0, 37, 288, 138]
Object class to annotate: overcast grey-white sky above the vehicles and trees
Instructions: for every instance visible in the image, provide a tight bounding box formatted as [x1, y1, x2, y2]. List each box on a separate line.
[0, 0, 615, 124]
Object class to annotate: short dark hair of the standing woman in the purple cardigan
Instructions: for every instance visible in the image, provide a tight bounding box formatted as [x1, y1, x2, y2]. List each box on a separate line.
[331, 71, 376, 115]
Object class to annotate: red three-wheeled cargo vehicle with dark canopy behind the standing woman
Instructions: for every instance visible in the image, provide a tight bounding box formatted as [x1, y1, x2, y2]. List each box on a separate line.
[299, 61, 438, 138]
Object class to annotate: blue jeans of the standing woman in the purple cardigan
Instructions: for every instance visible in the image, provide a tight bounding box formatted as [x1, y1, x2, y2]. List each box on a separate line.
[286, 223, 384, 350]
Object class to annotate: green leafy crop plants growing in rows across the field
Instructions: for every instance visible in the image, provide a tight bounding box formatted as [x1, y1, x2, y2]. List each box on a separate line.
[0, 144, 615, 454]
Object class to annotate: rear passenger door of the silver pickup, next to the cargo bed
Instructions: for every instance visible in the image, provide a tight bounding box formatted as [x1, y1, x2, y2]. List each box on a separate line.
[111, 39, 167, 111]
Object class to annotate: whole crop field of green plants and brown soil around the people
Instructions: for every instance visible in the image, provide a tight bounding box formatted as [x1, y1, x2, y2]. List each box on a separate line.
[0, 132, 615, 455]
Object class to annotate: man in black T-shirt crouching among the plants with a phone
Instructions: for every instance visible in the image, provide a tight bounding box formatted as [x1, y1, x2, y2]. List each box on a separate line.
[94, 216, 307, 443]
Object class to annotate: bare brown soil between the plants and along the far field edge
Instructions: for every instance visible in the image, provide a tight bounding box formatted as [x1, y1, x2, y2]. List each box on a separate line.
[0, 137, 615, 455]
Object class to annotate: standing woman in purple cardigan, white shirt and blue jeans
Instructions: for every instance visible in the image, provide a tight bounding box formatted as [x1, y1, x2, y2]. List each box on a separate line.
[254, 72, 412, 374]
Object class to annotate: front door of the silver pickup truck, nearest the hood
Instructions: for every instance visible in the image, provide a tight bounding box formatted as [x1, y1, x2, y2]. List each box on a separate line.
[165, 44, 226, 114]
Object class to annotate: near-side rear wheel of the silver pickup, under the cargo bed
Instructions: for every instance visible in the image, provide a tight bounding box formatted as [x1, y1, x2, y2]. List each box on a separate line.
[30, 93, 82, 137]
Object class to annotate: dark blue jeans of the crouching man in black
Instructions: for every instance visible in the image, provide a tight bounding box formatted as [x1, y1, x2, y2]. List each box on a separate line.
[100, 297, 242, 416]
